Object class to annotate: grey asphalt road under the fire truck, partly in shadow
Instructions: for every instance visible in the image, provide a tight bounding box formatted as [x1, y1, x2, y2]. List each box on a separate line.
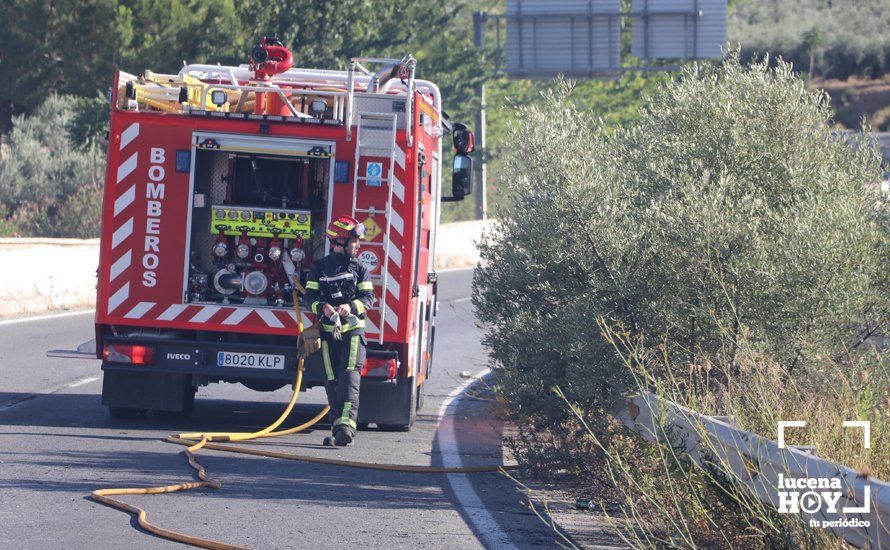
[0, 270, 555, 549]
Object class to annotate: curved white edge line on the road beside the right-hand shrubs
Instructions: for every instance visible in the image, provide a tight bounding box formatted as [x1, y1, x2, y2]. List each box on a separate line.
[436, 369, 516, 548]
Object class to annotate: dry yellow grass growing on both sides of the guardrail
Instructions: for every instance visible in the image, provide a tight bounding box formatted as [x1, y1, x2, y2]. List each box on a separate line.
[548, 330, 890, 548]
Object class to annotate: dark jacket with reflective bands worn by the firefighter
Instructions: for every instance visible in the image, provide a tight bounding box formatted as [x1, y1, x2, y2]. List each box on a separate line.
[306, 253, 374, 332]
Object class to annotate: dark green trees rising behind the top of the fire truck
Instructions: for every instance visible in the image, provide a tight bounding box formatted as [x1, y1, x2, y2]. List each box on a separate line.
[0, 0, 482, 131]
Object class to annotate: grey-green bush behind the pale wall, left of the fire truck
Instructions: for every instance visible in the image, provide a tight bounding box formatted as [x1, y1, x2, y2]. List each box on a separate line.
[0, 95, 105, 237]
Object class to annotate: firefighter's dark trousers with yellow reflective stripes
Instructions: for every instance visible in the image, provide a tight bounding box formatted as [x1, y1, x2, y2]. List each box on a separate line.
[321, 332, 365, 430]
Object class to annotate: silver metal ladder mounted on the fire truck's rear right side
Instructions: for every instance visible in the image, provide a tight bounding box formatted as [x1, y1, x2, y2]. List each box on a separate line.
[352, 113, 399, 344]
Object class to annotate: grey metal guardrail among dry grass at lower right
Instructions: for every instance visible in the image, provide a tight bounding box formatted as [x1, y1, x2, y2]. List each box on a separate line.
[618, 393, 890, 548]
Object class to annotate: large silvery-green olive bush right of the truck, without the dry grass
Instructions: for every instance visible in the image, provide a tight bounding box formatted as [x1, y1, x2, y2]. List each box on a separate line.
[474, 53, 890, 426]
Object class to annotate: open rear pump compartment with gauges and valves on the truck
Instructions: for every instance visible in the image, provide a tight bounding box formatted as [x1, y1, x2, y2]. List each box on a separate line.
[184, 136, 333, 308]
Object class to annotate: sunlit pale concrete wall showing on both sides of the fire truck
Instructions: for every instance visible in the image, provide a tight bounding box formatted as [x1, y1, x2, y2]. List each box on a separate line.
[0, 221, 491, 317]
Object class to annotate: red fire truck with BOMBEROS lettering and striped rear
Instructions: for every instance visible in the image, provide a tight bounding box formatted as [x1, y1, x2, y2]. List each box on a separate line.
[96, 37, 473, 430]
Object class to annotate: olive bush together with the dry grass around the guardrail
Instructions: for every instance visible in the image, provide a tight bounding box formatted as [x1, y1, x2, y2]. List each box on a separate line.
[473, 51, 890, 548]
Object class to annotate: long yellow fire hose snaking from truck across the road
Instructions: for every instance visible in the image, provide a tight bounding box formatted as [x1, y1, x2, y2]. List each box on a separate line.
[90, 292, 517, 550]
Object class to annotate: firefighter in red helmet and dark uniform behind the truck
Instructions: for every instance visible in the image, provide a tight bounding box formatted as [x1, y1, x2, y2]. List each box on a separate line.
[306, 216, 374, 447]
